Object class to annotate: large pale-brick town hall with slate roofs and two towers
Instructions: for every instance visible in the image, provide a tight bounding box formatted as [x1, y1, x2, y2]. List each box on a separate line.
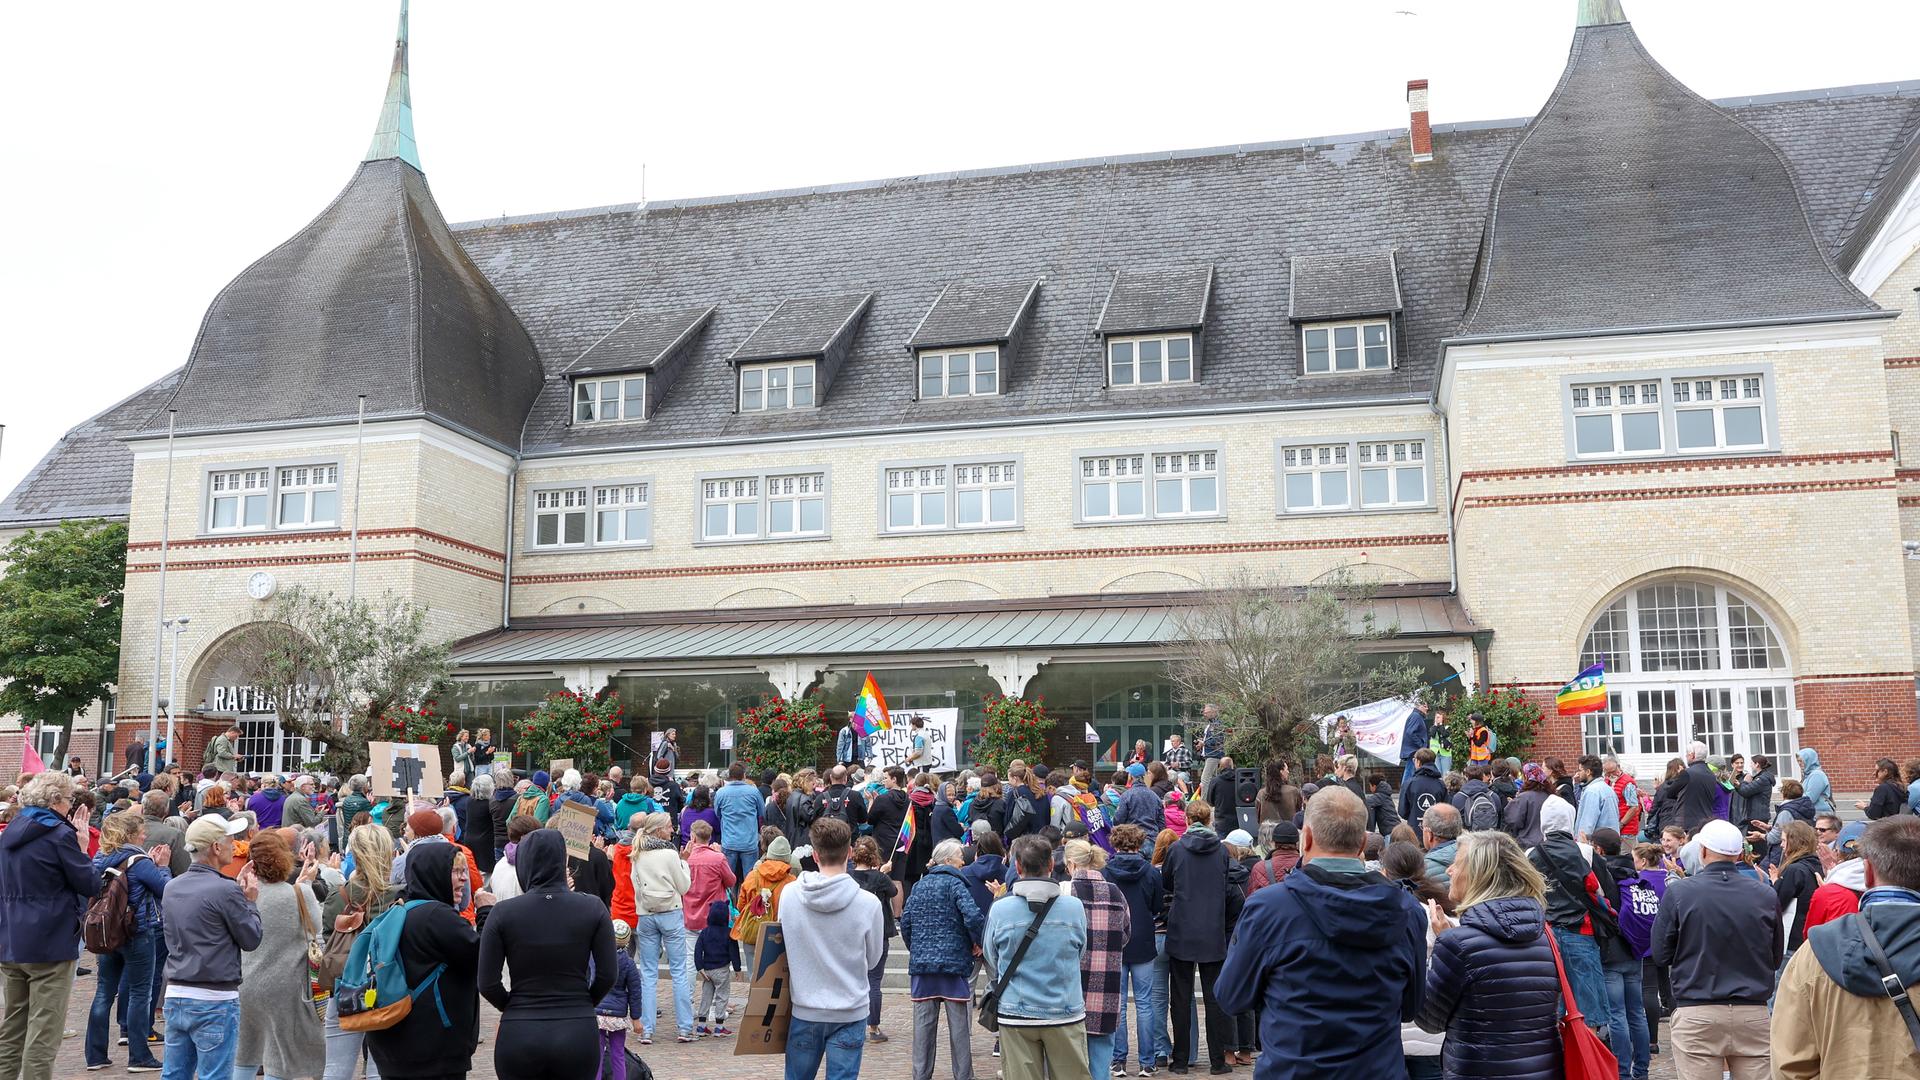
[0, 0, 1920, 786]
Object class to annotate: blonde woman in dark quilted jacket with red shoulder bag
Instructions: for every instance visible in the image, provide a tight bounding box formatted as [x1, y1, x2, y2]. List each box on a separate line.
[1413, 830, 1561, 1080]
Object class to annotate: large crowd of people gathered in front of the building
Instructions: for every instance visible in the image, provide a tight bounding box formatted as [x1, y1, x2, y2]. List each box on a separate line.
[0, 707, 1920, 1080]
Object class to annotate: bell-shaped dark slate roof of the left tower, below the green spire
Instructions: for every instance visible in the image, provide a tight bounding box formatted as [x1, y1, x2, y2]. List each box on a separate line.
[152, 158, 545, 448]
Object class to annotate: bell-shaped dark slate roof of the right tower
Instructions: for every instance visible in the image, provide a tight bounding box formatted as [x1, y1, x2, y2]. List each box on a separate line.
[1455, 23, 1878, 340]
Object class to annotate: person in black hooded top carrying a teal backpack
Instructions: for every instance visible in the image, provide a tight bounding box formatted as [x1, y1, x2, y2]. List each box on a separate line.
[362, 834, 487, 1080]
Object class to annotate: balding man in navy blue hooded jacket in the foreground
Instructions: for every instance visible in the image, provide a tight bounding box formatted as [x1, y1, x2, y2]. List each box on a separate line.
[1213, 784, 1427, 1080]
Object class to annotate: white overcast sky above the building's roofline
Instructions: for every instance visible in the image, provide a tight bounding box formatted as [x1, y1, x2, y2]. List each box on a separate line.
[0, 0, 1920, 492]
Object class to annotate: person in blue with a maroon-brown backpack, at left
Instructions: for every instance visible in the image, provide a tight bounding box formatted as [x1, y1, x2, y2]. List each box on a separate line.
[83, 811, 173, 1072]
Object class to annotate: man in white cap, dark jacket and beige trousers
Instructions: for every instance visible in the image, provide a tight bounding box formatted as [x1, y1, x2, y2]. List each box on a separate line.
[1649, 821, 1786, 1080]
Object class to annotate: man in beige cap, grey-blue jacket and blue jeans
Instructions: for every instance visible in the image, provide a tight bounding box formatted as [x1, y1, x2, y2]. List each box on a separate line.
[155, 815, 261, 1078]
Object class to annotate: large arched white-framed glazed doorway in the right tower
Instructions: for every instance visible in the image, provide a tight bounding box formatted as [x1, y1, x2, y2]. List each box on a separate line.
[1580, 578, 1795, 778]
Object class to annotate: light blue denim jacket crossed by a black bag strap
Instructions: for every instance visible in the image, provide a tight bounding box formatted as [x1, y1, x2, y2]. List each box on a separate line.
[985, 878, 1087, 1026]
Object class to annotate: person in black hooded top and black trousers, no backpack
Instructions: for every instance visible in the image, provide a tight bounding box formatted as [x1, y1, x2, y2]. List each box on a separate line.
[476, 828, 618, 1076]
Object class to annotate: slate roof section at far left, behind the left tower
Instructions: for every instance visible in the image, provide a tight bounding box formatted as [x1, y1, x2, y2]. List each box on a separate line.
[0, 371, 180, 528]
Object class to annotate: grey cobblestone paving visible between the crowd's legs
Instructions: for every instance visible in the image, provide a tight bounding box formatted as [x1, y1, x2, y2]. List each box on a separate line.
[37, 960, 1674, 1080]
